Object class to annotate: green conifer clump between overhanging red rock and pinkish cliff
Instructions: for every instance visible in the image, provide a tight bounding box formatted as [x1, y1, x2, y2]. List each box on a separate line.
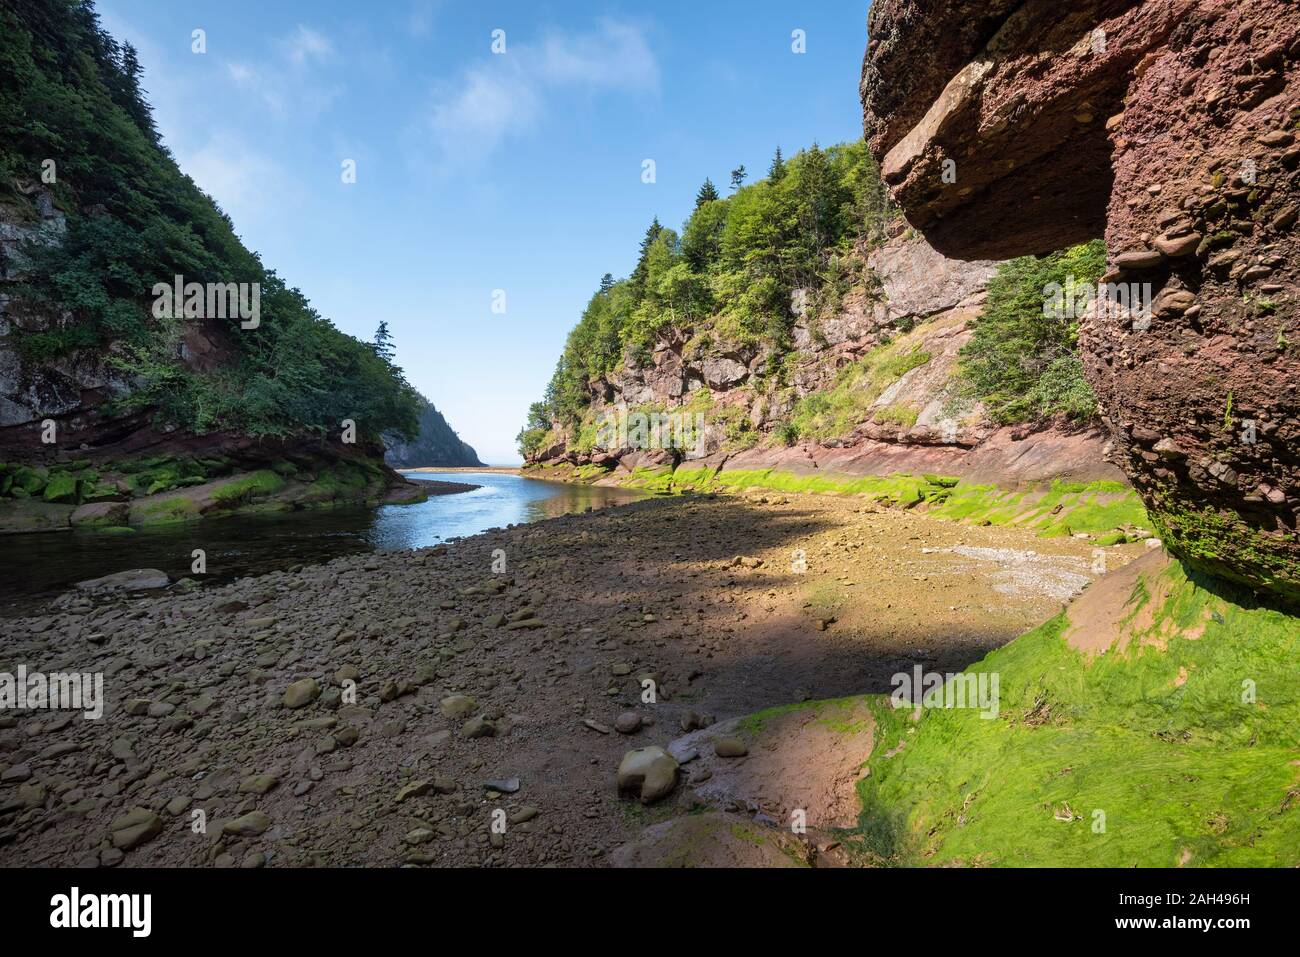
[957, 241, 1106, 424]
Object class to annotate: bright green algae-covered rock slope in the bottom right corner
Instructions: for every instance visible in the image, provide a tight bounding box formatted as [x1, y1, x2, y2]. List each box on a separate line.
[858, 562, 1300, 867]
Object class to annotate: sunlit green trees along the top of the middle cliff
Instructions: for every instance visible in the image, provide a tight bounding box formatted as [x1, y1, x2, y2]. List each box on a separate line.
[519, 142, 888, 447]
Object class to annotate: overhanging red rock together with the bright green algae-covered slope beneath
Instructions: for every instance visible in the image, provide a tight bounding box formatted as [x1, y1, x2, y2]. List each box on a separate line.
[816, 0, 1300, 867]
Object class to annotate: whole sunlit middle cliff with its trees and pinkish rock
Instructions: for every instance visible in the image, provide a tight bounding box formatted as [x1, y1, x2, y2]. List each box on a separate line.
[520, 143, 1122, 494]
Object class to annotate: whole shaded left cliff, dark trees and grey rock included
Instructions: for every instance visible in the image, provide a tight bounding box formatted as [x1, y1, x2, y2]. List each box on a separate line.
[0, 0, 467, 529]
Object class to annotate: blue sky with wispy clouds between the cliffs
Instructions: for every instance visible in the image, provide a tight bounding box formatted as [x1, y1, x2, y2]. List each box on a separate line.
[99, 0, 867, 464]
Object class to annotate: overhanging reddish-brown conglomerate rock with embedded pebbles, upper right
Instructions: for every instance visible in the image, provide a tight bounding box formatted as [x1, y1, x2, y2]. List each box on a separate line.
[862, 0, 1300, 602]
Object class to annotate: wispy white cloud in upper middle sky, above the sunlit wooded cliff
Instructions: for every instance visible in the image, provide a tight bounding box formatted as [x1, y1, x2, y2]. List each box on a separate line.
[423, 21, 659, 166]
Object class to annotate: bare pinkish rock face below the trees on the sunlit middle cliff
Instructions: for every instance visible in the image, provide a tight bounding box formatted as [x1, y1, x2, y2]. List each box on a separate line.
[530, 224, 1123, 486]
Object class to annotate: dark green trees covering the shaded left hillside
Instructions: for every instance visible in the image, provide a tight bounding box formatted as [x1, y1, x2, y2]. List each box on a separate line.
[0, 0, 419, 436]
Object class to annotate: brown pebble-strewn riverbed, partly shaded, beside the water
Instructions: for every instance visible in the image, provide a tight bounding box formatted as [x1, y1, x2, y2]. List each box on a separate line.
[0, 493, 1144, 866]
